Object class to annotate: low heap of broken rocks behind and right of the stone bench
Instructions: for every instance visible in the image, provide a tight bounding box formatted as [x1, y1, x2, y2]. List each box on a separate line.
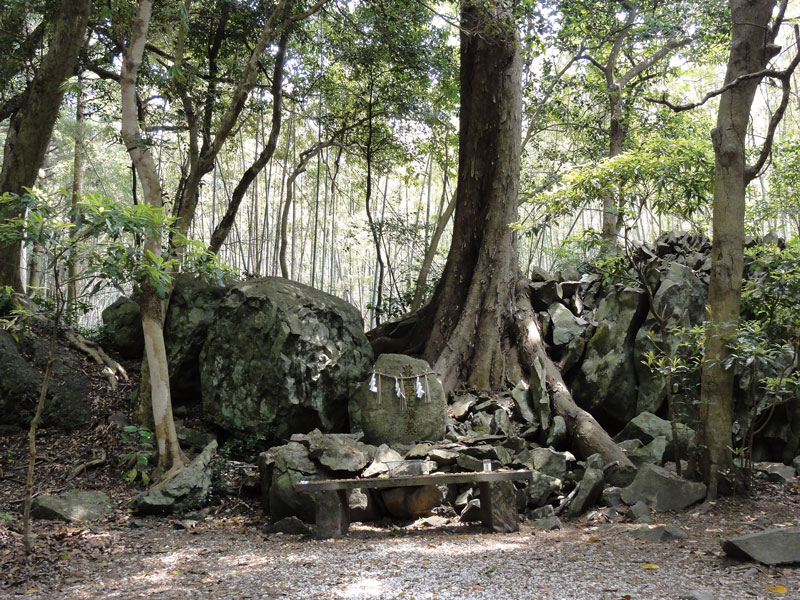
[258, 395, 752, 529]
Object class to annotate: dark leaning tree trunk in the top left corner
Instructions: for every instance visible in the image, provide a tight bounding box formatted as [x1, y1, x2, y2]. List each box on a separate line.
[0, 0, 91, 292]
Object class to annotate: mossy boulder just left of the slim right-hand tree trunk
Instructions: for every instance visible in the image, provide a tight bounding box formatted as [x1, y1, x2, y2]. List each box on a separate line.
[634, 263, 708, 412]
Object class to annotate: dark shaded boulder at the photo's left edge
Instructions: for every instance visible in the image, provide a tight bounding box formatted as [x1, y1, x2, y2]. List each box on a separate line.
[0, 329, 92, 431]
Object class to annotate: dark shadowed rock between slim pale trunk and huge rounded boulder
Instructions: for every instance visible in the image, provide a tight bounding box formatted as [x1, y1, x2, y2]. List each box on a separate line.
[161, 274, 228, 404]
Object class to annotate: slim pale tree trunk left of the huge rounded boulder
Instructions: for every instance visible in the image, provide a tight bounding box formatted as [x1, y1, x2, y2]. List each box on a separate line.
[120, 0, 187, 477]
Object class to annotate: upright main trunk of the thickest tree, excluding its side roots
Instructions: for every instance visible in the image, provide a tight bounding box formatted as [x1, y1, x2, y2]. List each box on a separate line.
[424, 0, 522, 389]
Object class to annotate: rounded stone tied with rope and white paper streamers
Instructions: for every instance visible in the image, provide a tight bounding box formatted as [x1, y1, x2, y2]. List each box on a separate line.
[350, 354, 450, 444]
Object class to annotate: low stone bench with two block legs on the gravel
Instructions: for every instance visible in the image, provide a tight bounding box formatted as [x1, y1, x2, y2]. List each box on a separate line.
[294, 471, 533, 538]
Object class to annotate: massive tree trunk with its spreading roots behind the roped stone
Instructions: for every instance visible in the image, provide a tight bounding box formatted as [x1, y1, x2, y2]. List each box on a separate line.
[369, 0, 633, 471]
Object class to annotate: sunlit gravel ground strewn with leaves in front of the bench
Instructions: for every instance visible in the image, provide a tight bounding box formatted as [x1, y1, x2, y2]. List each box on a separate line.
[0, 483, 800, 600]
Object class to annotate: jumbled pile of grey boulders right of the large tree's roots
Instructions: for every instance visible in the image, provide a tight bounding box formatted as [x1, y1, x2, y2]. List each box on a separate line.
[531, 233, 711, 428]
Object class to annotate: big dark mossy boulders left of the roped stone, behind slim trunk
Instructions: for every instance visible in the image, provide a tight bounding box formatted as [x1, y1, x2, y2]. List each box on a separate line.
[103, 276, 373, 444]
